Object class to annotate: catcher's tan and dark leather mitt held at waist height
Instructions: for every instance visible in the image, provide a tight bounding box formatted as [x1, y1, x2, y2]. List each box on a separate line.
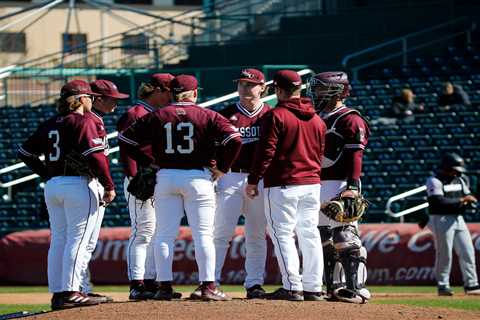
[321, 195, 370, 222]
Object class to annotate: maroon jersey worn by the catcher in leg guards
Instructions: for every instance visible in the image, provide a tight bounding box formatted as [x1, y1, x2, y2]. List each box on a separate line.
[320, 106, 370, 181]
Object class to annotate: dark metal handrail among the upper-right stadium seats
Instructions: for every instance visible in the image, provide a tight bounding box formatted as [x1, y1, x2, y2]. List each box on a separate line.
[341, 17, 476, 80]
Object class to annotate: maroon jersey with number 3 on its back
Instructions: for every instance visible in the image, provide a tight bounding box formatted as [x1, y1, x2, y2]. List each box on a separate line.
[18, 112, 114, 190]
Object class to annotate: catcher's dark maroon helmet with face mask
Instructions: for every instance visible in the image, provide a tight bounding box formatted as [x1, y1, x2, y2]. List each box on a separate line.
[307, 71, 350, 111]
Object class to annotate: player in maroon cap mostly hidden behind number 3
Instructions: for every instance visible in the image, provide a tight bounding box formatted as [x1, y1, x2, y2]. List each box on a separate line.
[81, 80, 129, 303]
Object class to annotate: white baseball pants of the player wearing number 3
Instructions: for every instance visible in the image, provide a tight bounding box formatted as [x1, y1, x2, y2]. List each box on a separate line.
[44, 176, 100, 293]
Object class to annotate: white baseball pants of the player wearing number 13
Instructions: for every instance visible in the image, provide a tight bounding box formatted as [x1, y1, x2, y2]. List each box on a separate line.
[154, 169, 215, 281]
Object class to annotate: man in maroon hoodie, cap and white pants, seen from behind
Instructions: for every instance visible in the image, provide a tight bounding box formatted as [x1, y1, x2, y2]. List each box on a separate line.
[246, 70, 326, 301]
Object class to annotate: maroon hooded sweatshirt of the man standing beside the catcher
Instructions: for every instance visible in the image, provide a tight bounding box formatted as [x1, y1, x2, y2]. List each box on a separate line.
[248, 98, 326, 188]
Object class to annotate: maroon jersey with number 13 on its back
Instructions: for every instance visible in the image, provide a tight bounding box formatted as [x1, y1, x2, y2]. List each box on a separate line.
[119, 102, 241, 172]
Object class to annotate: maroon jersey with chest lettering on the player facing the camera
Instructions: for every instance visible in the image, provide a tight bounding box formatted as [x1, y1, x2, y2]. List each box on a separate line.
[220, 102, 271, 171]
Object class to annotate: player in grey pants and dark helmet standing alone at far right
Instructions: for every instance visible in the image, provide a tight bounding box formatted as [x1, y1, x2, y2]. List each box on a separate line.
[427, 153, 480, 296]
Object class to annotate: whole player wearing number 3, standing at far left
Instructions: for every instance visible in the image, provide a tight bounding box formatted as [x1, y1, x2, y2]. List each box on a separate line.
[18, 80, 115, 310]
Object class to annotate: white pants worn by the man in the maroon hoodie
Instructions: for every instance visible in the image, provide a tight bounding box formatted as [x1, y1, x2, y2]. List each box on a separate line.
[265, 184, 323, 292]
